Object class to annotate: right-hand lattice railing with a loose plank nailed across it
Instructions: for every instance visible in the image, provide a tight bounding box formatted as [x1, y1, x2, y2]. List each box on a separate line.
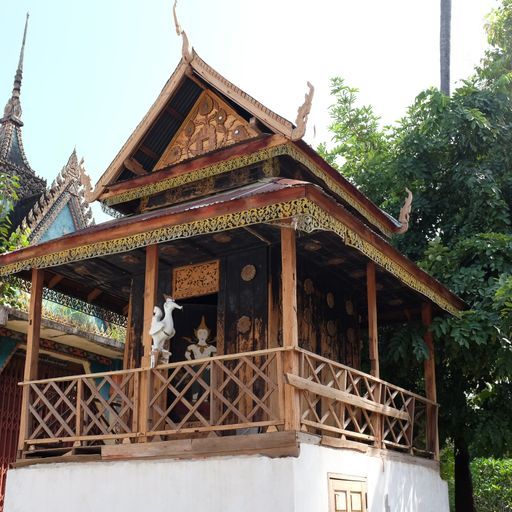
[287, 350, 437, 456]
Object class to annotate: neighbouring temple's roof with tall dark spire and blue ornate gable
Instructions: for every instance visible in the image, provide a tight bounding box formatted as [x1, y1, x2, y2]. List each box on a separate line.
[0, 14, 92, 242]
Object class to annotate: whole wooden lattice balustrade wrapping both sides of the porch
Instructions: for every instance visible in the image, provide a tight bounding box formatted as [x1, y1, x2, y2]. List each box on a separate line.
[18, 347, 437, 457]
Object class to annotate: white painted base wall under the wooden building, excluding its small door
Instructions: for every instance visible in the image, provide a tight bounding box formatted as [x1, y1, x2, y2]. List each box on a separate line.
[5, 443, 448, 512]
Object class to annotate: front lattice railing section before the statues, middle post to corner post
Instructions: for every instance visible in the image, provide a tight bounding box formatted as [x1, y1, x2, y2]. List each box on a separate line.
[148, 349, 284, 436]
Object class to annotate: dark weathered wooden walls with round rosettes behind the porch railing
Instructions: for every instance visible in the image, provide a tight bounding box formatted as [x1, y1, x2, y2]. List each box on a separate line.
[125, 244, 361, 368]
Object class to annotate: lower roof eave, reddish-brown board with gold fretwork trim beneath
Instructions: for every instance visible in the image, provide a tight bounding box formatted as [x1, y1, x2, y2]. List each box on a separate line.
[0, 179, 466, 314]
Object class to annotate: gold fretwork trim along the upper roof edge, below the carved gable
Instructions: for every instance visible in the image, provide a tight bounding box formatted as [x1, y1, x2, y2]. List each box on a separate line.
[103, 143, 392, 236]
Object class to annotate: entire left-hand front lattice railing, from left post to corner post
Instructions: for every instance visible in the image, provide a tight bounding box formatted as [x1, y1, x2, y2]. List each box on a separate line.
[23, 349, 284, 448]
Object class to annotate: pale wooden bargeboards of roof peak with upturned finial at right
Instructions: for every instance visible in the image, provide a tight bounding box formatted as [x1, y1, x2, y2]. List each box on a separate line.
[85, 51, 314, 202]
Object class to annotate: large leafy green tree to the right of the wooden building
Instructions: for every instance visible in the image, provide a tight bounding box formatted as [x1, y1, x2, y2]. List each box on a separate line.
[319, 0, 512, 512]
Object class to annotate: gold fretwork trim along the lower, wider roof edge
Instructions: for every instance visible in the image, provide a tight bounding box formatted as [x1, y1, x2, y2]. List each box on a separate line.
[0, 198, 459, 315]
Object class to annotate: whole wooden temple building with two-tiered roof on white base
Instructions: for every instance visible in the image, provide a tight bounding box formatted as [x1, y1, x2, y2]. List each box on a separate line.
[0, 11, 464, 512]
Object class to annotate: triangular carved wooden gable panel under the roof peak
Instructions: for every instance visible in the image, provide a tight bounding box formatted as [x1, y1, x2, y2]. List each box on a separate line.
[154, 91, 258, 171]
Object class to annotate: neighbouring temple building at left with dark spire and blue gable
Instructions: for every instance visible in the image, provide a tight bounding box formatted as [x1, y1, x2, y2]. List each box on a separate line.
[0, 16, 125, 512]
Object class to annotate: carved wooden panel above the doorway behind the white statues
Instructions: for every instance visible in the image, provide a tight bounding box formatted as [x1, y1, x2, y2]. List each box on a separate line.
[172, 260, 219, 300]
